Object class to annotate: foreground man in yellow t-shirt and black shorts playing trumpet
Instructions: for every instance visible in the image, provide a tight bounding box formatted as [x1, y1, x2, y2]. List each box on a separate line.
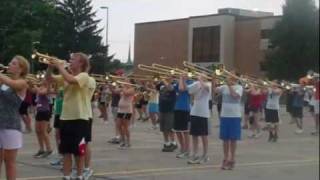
[47, 53, 94, 180]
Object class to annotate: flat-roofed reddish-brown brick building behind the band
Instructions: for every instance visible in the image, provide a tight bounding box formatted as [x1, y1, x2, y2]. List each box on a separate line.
[134, 8, 281, 76]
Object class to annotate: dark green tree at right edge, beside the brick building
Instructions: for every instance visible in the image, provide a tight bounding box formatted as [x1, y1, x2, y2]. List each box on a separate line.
[263, 0, 319, 80]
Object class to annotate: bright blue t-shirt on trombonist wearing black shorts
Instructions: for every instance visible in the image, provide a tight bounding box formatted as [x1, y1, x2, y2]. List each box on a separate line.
[174, 80, 192, 111]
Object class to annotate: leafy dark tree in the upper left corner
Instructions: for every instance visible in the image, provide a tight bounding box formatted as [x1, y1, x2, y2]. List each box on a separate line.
[0, 0, 55, 71]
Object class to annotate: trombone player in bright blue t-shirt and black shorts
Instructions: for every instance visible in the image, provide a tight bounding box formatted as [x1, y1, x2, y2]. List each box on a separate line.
[173, 75, 191, 159]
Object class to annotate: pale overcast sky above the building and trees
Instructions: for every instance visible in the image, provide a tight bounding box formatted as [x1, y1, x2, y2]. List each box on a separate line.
[92, 0, 319, 62]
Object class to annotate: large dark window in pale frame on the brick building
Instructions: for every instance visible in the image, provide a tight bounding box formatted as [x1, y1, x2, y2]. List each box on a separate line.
[192, 26, 220, 63]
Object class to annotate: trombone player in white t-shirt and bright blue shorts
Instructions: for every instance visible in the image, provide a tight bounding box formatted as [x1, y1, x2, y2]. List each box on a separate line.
[212, 76, 243, 170]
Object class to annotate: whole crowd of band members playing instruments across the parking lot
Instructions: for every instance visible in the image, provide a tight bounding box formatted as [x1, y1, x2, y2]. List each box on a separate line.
[0, 53, 319, 180]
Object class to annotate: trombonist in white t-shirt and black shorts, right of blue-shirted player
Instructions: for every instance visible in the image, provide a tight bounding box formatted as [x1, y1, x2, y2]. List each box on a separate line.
[187, 76, 211, 164]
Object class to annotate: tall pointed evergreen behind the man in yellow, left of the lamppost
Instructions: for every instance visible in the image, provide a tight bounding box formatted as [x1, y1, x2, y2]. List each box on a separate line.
[57, 0, 113, 74]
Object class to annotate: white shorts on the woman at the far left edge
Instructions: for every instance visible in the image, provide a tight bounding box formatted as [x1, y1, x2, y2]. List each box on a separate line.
[0, 129, 22, 150]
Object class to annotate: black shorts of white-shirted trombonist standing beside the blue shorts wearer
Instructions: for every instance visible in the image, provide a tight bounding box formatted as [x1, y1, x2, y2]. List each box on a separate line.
[190, 115, 209, 136]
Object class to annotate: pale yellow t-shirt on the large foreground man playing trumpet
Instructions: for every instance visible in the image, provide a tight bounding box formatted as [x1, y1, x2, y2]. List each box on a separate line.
[55, 72, 92, 120]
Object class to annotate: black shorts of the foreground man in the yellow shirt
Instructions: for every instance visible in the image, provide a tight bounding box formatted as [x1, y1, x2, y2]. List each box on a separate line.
[59, 119, 89, 156]
